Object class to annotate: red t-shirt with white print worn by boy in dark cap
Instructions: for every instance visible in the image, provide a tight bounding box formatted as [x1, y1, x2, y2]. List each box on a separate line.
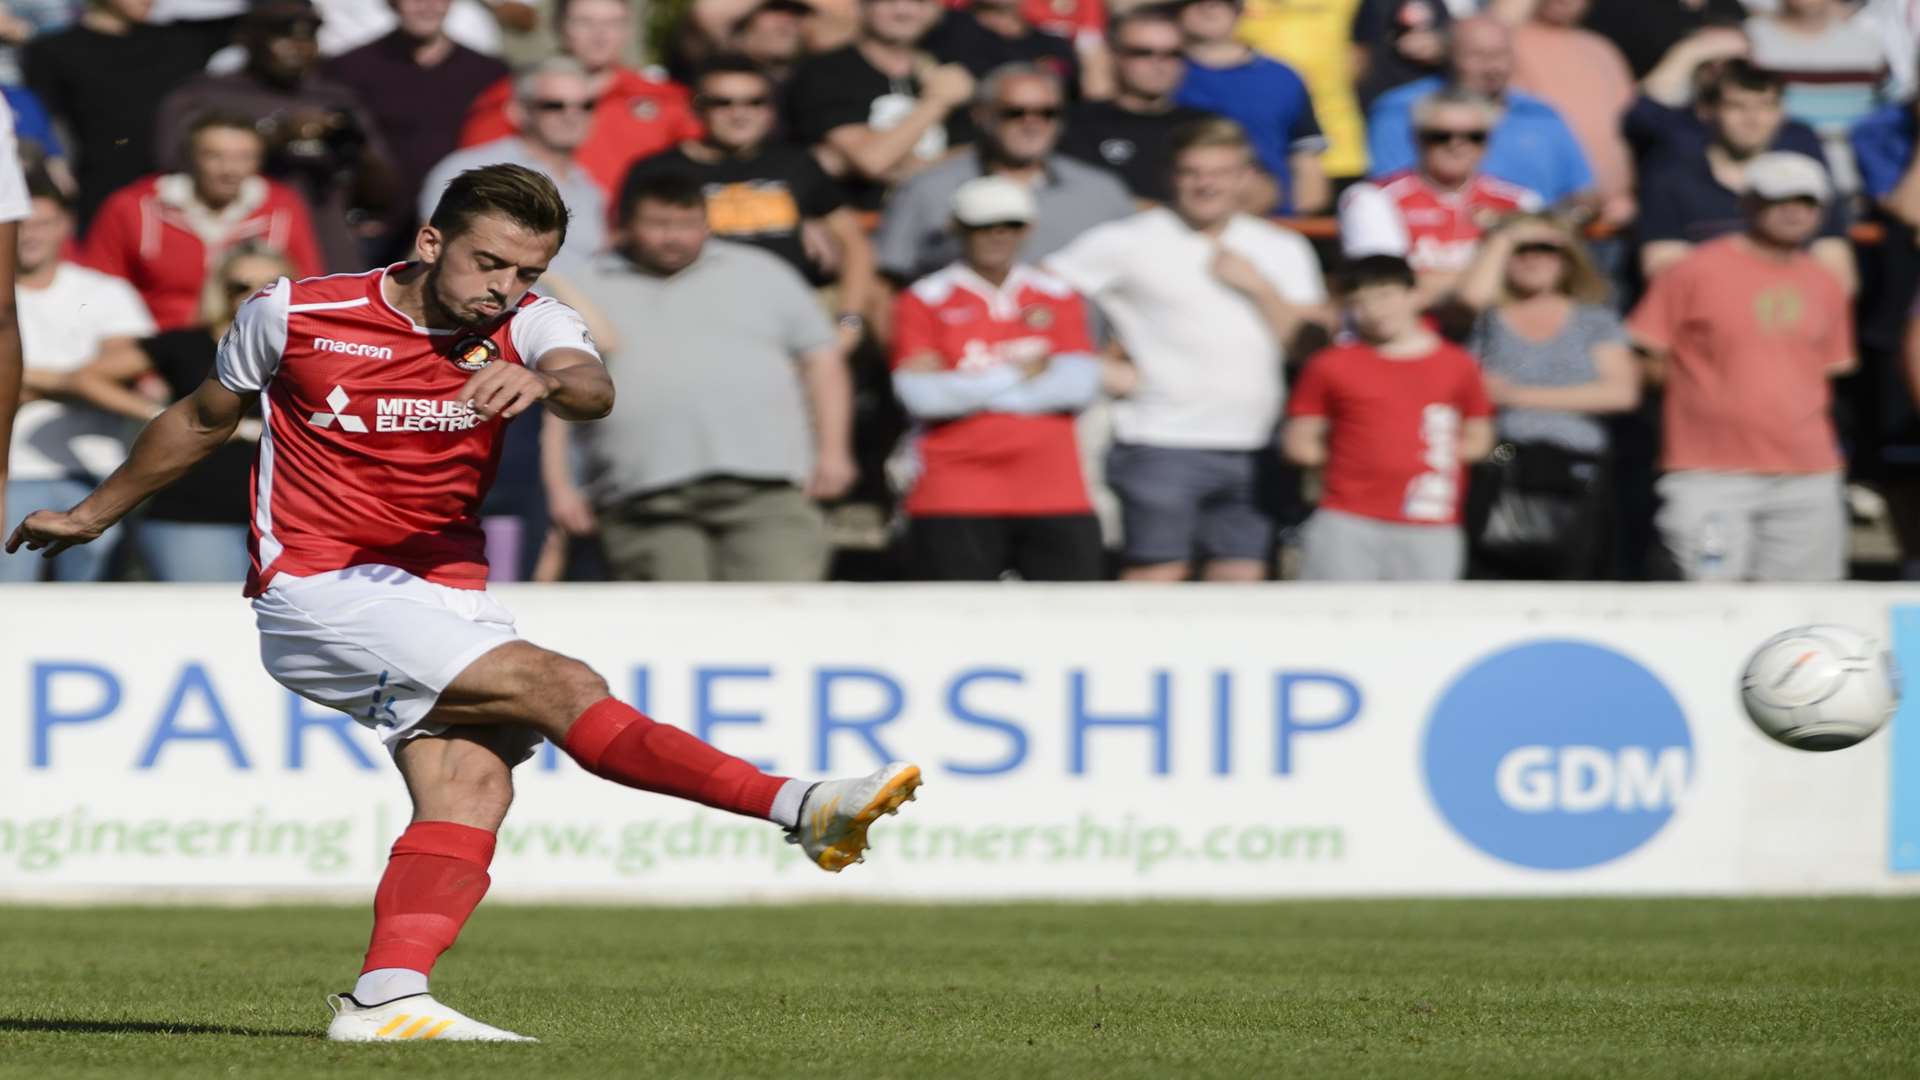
[1286, 342, 1494, 525]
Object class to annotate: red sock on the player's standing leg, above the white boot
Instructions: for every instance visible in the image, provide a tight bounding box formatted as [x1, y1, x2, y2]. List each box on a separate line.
[361, 821, 493, 974]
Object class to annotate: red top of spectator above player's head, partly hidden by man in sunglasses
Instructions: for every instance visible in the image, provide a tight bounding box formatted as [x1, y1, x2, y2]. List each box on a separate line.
[461, 67, 705, 195]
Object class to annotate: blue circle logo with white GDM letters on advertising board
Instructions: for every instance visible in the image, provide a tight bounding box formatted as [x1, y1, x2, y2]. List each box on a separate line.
[1421, 642, 1693, 871]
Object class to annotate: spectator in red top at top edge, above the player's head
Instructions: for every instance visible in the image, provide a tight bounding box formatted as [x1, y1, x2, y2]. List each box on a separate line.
[461, 0, 701, 200]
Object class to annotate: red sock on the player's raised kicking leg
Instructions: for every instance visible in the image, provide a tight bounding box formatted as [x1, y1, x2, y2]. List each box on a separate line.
[566, 698, 787, 817]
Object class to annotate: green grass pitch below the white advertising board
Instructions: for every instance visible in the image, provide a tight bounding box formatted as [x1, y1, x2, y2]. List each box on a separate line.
[0, 899, 1920, 1080]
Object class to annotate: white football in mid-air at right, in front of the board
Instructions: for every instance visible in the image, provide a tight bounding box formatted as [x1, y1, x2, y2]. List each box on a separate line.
[1740, 626, 1901, 749]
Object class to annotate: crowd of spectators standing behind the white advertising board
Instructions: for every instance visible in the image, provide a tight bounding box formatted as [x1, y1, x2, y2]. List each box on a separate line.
[0, 0, 1920, 582]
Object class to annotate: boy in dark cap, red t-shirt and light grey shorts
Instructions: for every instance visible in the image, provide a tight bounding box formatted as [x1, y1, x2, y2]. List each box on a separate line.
[1281, 256, 1494, 580]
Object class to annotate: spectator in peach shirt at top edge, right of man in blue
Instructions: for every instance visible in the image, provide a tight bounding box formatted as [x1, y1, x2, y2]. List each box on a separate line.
[1513, 0, 1634, 223]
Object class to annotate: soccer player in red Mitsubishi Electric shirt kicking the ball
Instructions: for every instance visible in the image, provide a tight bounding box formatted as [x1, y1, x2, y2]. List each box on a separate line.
[6, 165, 920, 1042]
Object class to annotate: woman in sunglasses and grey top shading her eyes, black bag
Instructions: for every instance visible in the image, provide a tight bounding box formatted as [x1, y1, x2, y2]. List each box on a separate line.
[1459, 215, 1640, 580]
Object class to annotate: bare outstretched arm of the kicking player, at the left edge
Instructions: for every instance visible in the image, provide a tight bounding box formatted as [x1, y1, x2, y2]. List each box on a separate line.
[6, 379, 246, 557]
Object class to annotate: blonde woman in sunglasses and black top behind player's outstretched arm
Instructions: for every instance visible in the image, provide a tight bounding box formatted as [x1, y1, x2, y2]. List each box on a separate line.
[71, 244, 300, 582]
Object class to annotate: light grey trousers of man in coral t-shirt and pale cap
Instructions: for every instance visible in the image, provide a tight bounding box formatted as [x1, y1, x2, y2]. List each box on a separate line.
[1653, 469, 1847, 580]
